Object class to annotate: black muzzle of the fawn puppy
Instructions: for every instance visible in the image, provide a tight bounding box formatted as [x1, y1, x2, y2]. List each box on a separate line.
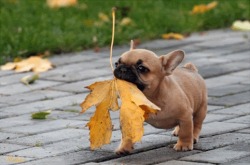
[114, 64, 145, 91]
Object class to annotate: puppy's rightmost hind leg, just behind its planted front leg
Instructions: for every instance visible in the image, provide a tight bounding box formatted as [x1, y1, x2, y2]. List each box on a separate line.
[193, 102, 207, 144]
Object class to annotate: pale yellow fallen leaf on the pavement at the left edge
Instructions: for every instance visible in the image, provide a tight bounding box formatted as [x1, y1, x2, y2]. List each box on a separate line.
[1, 56, 52, 72]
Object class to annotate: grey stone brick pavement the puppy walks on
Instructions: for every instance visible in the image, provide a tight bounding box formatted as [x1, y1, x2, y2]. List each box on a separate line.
[0, 29, 250, 165]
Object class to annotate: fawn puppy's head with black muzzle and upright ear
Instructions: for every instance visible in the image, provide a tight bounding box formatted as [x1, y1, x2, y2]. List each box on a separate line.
[114, 49, 184, 94]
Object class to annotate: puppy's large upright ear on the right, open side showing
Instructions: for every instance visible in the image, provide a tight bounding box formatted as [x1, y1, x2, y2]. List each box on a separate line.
[160, 50, 185, 75]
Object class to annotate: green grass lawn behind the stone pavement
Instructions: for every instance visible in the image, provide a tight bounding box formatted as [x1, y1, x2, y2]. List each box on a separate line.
[0, 0, 250, 64]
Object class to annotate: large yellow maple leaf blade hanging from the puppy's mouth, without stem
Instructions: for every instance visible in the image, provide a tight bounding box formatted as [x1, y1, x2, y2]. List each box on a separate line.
[81, 78, 160, 149]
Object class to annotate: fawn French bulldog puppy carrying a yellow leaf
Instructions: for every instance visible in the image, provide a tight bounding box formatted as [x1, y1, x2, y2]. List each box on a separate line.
[114, 44, 207, 155]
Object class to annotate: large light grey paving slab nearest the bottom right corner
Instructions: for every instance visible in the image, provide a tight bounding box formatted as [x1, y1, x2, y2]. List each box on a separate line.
[181, 142, 250, 163]
